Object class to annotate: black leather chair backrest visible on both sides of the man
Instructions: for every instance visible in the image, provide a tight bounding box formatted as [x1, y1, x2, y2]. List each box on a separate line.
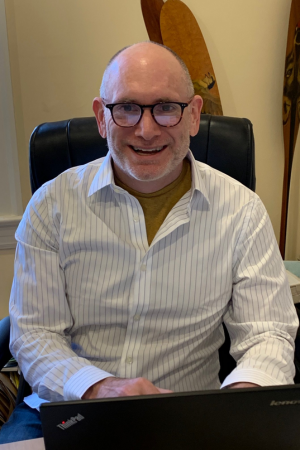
[29, 114, 255, 193]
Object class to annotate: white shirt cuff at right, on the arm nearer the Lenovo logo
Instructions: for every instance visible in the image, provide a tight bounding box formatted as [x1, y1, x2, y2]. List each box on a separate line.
[220, 368, 284, 389]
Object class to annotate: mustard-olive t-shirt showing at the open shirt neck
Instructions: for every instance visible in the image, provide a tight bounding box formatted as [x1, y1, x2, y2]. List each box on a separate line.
[115, 158, 192, 245]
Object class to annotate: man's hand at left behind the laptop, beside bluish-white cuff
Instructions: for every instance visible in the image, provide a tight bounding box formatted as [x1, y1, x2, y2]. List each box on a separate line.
[82, 377, 172, 399]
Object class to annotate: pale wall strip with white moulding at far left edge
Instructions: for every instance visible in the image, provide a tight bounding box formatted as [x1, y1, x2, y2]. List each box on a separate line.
[0, 0, 23, 319]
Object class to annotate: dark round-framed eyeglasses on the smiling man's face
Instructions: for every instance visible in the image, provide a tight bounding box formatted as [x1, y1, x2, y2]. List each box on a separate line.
[105, 100, 192, 128]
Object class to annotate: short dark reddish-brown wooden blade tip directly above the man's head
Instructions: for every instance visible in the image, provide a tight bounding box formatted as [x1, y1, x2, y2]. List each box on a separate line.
[141, 0, 164, 44]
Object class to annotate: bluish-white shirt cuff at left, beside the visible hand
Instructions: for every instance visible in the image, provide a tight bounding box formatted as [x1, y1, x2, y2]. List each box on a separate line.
[64, 366, 114, 401]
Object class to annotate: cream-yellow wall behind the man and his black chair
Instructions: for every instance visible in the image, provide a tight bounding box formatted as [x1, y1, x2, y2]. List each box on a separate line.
[0, 0, 300, 316]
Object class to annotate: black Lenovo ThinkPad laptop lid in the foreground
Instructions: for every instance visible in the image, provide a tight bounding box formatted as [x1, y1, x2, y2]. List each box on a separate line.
[40, 385, 300, 450]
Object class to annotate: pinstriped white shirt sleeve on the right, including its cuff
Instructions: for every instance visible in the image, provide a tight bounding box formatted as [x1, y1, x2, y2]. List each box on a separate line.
[221, 197, 299, 387]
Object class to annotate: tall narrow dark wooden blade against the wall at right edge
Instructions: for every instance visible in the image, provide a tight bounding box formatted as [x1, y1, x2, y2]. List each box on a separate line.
[279, 0, 300, 258]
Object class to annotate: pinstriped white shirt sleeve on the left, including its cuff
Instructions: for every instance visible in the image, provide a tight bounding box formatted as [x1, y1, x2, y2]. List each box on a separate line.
[10, 183, 112, 401]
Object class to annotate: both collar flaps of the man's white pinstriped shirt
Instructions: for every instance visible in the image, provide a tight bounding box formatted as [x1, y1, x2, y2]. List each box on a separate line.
[88, 150, 209, 203]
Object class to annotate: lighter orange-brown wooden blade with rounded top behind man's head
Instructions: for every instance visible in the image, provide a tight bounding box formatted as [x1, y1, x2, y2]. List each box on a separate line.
[160, 0, 223, 115]
